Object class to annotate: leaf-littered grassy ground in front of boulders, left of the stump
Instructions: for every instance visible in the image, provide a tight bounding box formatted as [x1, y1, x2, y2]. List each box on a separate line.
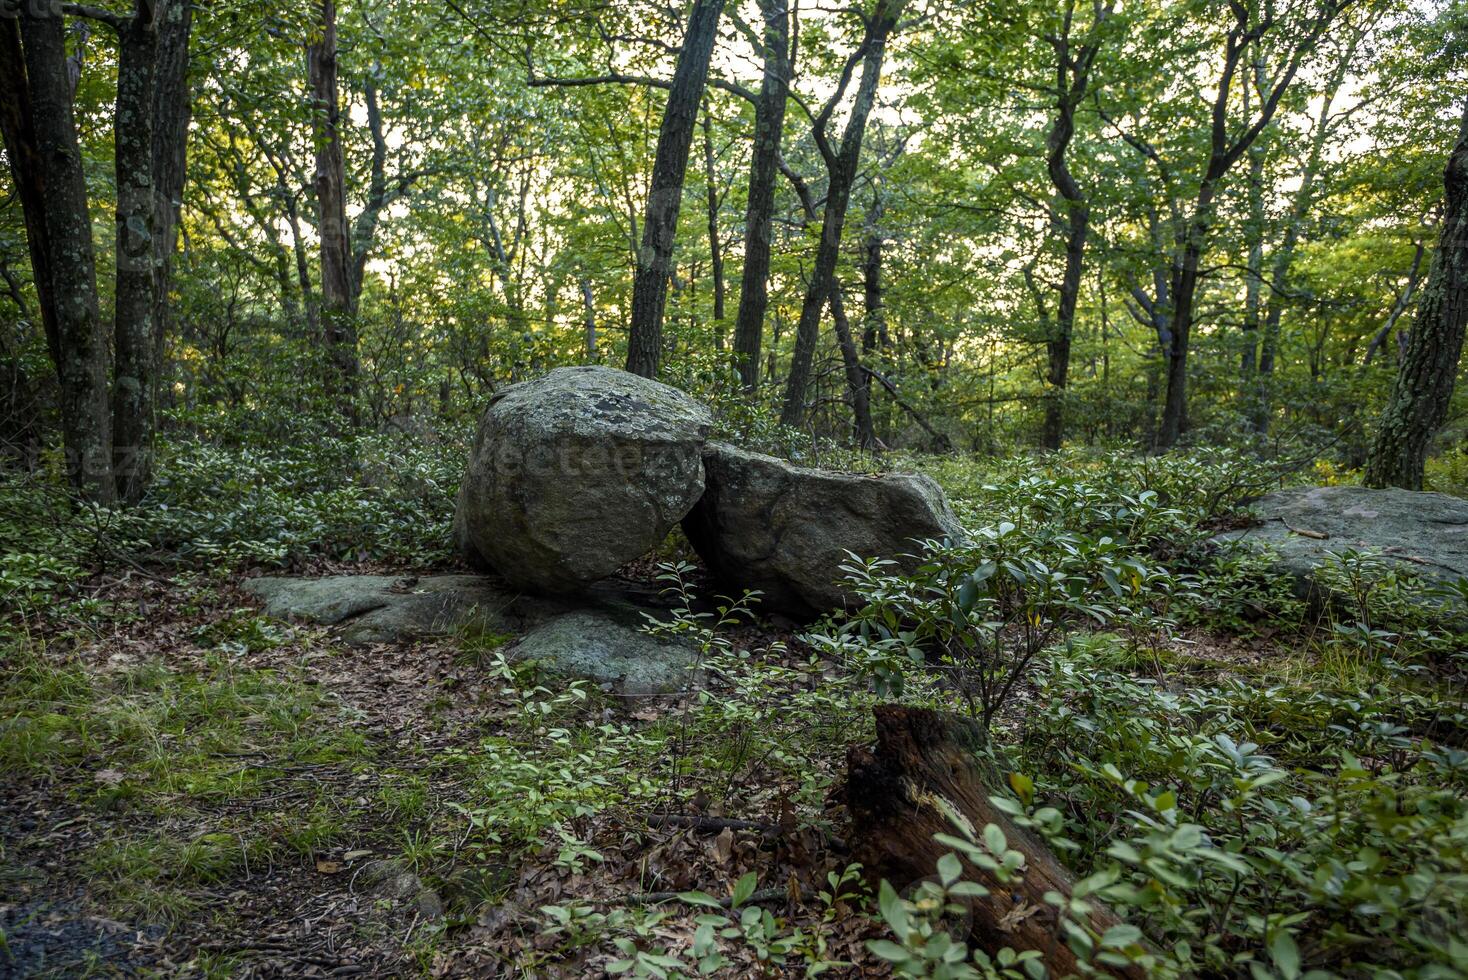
[0, 565, 885, 977]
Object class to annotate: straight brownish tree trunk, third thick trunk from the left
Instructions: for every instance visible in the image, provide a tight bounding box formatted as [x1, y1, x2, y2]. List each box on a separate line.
[307, 0, 357, 421]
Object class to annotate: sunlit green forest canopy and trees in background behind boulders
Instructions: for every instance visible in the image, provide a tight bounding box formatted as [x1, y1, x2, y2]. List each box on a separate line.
[0, 0, 1468, 478]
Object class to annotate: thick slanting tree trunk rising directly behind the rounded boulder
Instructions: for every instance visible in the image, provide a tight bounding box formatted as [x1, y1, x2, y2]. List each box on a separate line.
[627, 0, 724, 377]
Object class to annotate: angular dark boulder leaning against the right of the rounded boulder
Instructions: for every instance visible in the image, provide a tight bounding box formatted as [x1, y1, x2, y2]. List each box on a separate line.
[683, 443, 964, 618]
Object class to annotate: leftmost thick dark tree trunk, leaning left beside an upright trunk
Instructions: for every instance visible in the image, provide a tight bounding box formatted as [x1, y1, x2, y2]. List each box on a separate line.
[6, 4, 116, 503]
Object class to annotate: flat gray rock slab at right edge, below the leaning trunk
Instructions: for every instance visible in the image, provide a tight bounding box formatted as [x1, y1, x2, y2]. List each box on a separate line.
[1214, 487, 1468, 591]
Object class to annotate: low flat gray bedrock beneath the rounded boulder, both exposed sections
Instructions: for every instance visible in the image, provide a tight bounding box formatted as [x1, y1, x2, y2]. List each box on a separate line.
[244, 575, 697, 697]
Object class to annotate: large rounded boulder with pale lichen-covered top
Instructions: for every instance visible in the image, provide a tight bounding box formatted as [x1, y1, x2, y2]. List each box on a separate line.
[454, 367, 712, 593]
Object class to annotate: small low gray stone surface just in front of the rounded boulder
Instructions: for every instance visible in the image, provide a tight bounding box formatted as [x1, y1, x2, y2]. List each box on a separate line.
[509, 610, 696, 697]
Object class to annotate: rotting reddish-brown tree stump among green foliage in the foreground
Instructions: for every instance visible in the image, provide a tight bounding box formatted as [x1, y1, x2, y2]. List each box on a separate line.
[844, 704, 1147, 980]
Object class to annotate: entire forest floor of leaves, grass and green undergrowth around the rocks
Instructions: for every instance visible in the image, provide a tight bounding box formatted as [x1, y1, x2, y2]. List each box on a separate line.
[0, 456, 1468, 980]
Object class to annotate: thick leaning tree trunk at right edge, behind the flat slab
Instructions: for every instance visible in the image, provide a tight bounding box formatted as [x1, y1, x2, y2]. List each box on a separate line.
[1365, 101, 1468, 490]
